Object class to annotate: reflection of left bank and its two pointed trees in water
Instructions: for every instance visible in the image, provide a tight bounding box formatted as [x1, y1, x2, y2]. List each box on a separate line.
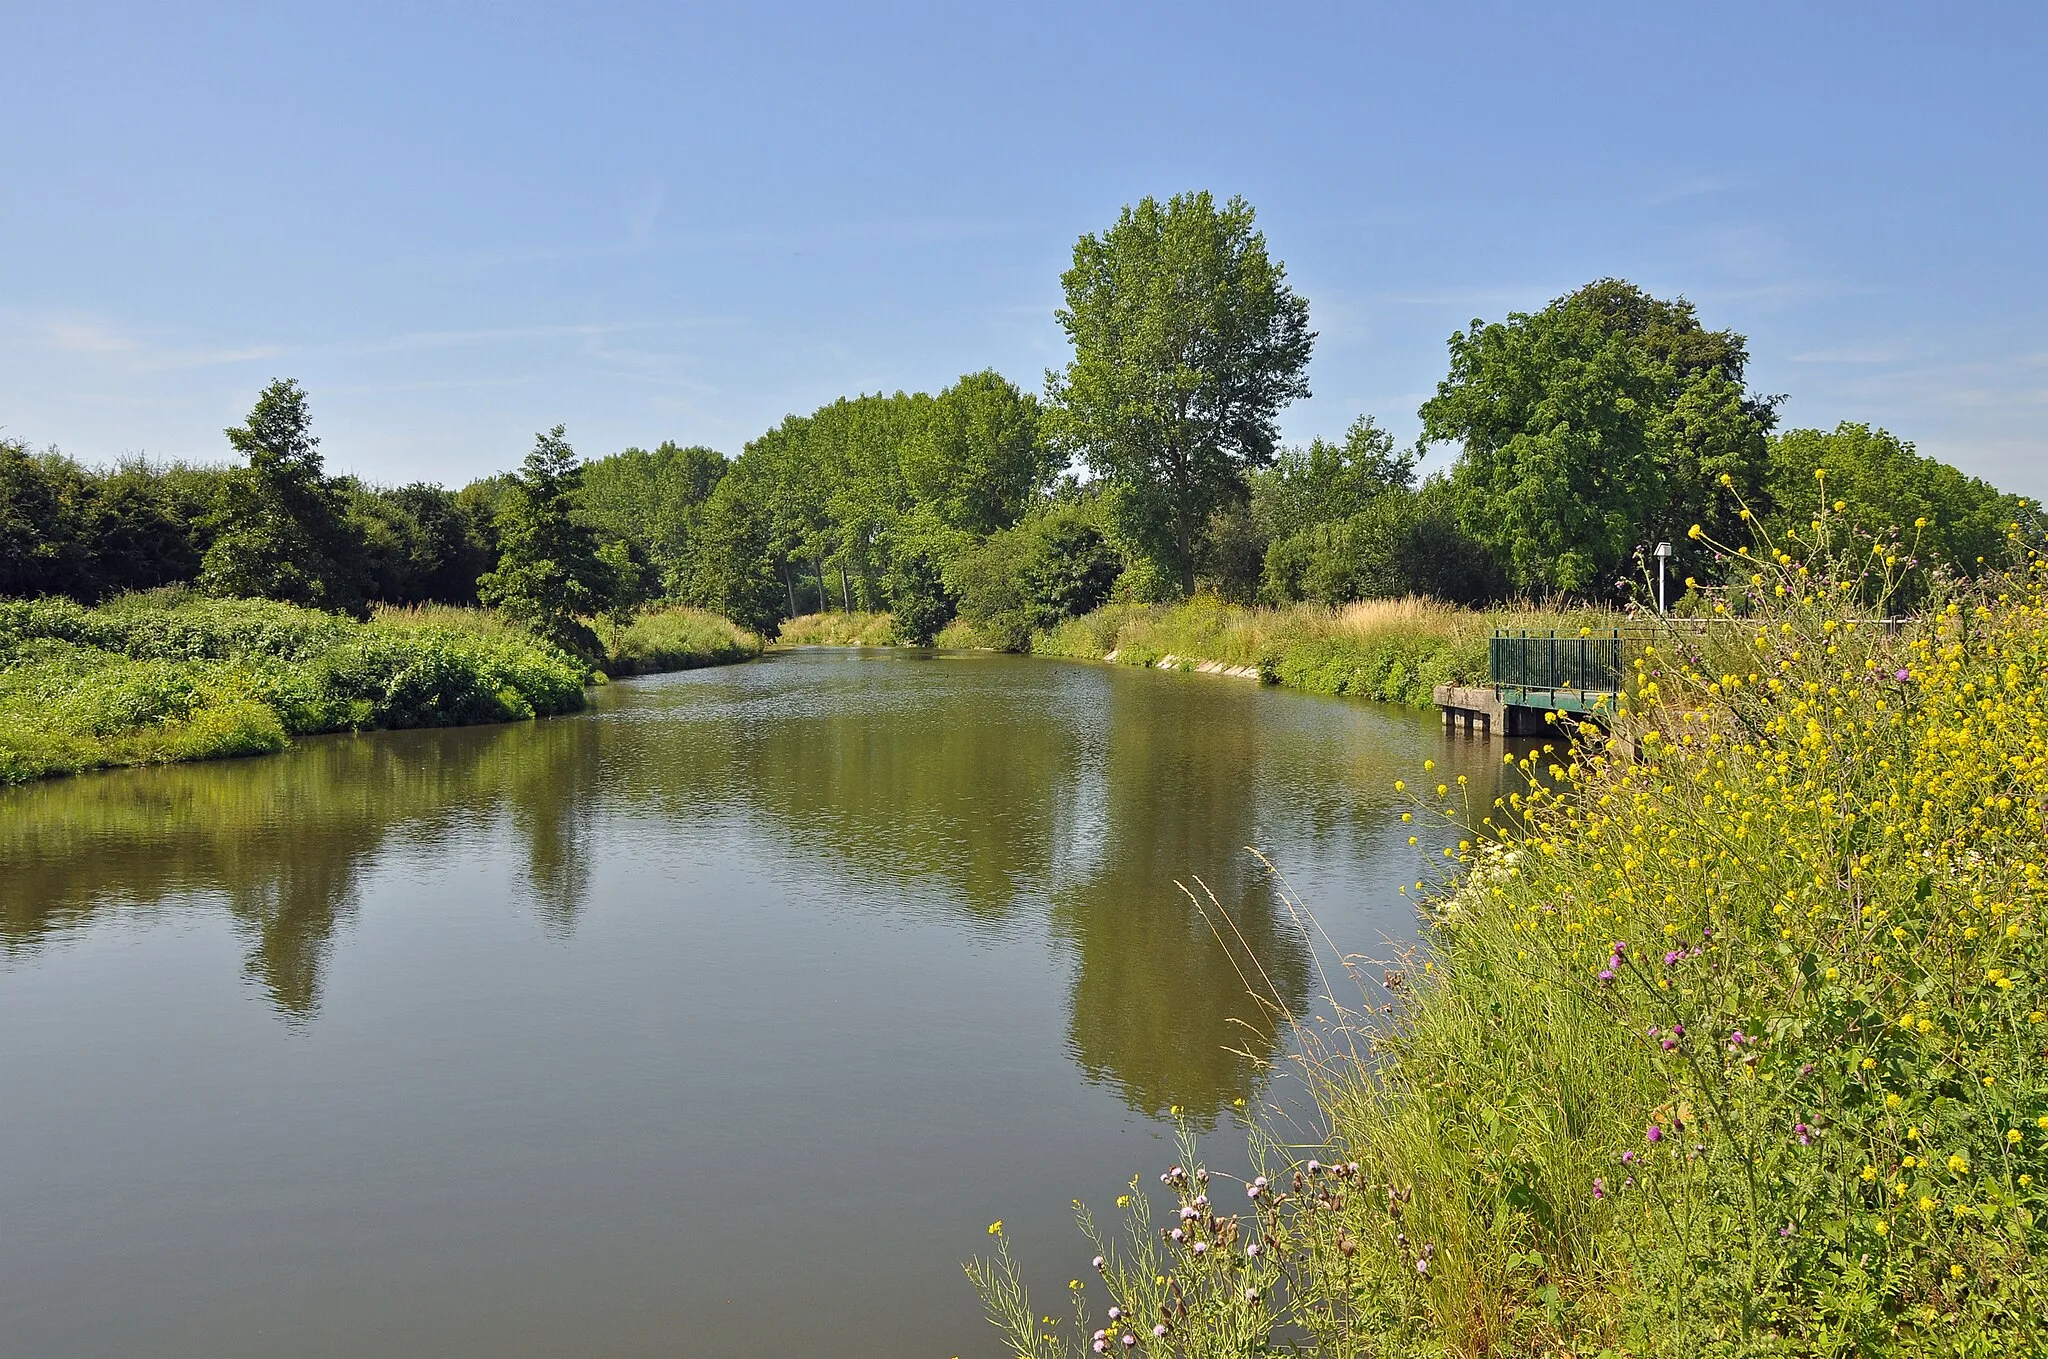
[0, 720, 596, 1019]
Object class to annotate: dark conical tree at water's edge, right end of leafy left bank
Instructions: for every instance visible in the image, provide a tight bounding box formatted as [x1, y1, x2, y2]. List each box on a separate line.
[477, 426, 618, 659]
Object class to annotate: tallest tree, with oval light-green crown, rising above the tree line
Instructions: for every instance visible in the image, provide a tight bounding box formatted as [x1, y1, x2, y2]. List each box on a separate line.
[1047, 192, 1315, 594]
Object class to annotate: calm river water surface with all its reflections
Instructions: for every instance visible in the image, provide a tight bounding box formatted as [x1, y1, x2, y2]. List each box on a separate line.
[0, 651, 1501, 1359]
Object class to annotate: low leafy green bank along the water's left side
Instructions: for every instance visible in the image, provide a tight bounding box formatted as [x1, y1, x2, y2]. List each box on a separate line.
[0, 589, 760, 784]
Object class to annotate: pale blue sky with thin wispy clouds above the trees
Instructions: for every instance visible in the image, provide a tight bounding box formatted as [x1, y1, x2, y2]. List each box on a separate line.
[0, 0, 2048, 495]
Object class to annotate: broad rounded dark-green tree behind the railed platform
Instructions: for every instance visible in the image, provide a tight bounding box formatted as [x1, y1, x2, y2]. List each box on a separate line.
[1421, 278, 1774, 596]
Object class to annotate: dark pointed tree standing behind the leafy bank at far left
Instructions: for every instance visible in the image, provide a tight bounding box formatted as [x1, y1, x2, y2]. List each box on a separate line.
[199, 379, 369, 614]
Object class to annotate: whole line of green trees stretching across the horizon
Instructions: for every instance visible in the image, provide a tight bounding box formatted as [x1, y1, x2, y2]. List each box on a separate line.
[0, 192, 2021, 653]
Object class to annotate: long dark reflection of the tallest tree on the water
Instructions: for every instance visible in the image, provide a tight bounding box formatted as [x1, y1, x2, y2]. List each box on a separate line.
[1055, 684, 1311, 1120]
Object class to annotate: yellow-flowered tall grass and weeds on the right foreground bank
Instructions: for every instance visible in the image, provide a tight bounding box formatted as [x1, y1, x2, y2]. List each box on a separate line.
[971, 515, 2048, 1357]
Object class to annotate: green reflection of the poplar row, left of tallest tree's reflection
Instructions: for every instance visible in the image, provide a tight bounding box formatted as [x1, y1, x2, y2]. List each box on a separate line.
[606, 655, 1092, 919]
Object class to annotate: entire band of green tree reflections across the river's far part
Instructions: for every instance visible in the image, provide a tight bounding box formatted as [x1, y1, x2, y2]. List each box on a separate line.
[0, 653, 1491, 1122]
